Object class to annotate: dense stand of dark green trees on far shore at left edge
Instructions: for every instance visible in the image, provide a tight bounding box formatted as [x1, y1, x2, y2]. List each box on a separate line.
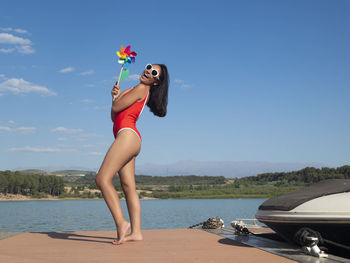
[0, 171, 64, 196]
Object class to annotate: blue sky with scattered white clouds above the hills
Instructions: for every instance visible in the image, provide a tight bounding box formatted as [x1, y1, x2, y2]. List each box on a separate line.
[0, 0, 350, 170]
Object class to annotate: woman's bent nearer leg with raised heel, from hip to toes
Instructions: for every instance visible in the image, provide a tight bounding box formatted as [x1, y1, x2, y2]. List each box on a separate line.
[96, 130, 141, 245]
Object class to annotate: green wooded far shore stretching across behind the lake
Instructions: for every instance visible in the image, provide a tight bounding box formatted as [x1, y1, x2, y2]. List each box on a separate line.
[0, 165, 350, 198]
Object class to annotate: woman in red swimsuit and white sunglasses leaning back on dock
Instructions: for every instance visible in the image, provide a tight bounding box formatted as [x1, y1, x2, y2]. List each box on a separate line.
[96, 64, 169, 245]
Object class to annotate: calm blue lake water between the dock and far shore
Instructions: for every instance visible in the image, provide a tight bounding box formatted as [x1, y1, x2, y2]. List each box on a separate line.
[0, 199, 265, 232]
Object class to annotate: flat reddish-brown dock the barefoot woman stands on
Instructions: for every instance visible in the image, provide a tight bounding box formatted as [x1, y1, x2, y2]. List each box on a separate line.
[0, 229, 296, 263]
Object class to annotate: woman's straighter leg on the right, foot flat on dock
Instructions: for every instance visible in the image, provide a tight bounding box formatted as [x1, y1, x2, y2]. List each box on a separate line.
[119, 157, 143, 241]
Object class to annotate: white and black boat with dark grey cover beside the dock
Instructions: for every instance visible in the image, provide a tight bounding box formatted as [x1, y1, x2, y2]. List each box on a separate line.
[256, 179, 350, 255]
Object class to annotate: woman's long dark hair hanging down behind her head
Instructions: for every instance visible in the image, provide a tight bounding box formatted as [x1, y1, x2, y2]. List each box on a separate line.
[147, 64, 169, 117]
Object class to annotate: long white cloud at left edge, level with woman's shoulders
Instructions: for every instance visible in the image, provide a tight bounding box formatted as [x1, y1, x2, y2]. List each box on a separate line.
[0, 78, 57, 96]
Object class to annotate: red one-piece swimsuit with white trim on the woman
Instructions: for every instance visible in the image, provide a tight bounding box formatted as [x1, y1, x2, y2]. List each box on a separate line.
[113, 89, 149, 140]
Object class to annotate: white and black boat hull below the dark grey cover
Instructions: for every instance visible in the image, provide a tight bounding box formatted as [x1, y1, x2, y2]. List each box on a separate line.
[255, 189, 350, 256]
